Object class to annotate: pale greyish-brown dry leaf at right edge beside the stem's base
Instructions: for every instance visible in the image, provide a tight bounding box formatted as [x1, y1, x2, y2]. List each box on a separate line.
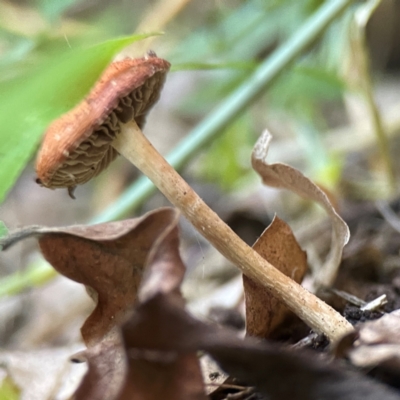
[342, 310, 400, 374]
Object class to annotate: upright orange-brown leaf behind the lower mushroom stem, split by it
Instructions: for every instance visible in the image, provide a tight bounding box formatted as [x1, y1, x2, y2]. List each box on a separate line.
[243, 216, 307, 338]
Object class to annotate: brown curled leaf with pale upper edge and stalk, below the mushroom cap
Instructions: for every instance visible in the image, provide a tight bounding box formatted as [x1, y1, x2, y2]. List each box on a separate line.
[0, 208, 178, 346]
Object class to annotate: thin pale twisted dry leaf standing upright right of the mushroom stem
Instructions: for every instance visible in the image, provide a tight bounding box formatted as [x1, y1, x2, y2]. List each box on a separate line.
[252, 131, 350, 286]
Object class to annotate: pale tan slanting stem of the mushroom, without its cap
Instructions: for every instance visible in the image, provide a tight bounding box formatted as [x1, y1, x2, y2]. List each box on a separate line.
[113, 122, 353, 341]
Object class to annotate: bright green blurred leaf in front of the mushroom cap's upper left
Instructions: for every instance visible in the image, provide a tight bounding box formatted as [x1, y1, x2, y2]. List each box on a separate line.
[0, 33, 160, 203]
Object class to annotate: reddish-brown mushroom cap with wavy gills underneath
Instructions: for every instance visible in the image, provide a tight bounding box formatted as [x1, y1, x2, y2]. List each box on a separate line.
[36, 53, 170, 194]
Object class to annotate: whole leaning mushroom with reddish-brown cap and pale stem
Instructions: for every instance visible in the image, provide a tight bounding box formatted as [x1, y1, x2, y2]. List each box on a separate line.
[37, 53, 353, 340]
